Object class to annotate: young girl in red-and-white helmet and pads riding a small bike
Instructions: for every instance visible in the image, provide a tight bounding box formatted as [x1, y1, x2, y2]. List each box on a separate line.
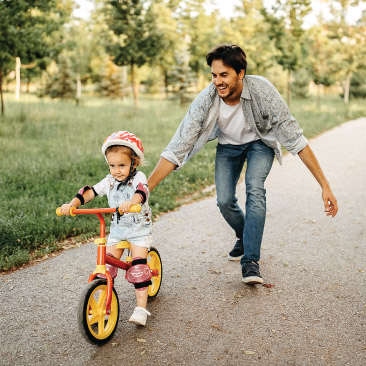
[61, 131, 152, 326]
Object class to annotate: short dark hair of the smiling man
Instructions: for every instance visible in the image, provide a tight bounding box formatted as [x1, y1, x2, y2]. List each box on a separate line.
[206, 44, 247, 74]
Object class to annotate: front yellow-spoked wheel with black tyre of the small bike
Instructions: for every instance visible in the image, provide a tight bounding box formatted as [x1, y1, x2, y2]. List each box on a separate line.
[78, 279, 119, 345]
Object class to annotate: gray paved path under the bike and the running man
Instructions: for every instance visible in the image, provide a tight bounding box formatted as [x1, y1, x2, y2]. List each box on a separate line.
[0, 118, 366, 366]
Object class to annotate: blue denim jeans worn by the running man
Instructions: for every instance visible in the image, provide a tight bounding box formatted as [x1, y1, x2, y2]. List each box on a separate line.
[215, 140, 274, 264]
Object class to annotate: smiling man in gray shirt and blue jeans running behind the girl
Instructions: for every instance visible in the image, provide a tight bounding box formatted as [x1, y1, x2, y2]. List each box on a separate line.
[148, 45, 338, 284]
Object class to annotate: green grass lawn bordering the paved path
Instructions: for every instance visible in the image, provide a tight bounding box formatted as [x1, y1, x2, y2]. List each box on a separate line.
[0, 91, 366, 270]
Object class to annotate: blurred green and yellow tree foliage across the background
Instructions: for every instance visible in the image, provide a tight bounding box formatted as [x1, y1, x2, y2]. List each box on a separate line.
[0, 0, 366, 104]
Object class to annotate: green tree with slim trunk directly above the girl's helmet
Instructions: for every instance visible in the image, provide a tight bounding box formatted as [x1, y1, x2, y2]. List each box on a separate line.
[105, 0, 163, 107]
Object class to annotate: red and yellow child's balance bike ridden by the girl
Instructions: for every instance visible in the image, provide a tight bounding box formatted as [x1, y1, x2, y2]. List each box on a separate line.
[56, 205, 163, 345]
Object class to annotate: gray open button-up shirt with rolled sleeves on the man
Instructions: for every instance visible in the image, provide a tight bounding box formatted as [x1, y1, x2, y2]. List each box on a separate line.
[161, 75, 309, 169]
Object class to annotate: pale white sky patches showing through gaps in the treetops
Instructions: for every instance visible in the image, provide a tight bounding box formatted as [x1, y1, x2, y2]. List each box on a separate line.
[74, 0, 366, 27]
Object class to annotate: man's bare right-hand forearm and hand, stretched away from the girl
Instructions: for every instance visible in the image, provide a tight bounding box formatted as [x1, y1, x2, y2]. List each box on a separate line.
[298, 145, 338, 217]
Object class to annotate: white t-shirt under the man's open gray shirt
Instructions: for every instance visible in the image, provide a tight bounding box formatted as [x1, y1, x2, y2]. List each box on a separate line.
[217, 98, 259, 145]
